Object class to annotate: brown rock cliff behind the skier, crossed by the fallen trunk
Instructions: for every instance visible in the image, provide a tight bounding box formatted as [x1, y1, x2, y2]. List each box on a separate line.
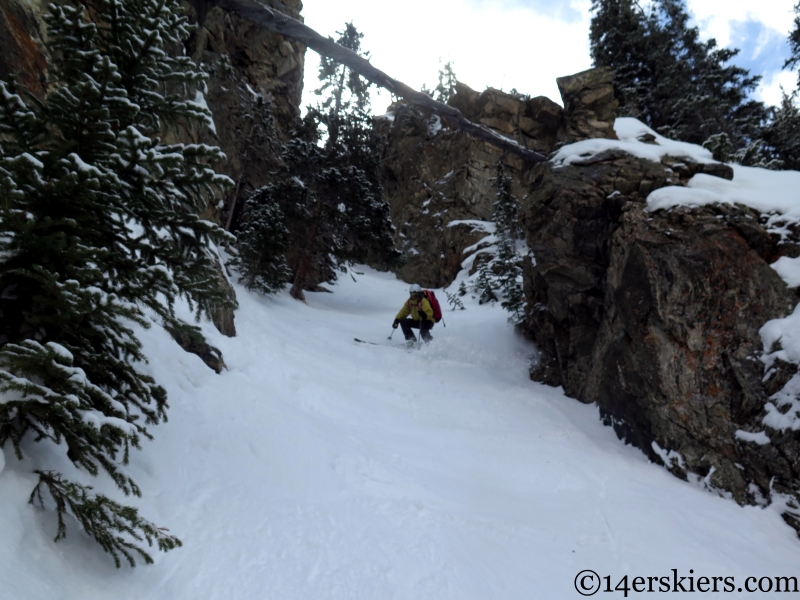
[381, 83, 564, 287]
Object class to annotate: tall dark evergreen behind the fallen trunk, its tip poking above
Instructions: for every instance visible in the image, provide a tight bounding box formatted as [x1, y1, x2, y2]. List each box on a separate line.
[282, 23, 401, 299]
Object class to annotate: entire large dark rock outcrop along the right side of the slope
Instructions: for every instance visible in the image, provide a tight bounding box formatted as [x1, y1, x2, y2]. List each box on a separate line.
[522, 148, 800, 529]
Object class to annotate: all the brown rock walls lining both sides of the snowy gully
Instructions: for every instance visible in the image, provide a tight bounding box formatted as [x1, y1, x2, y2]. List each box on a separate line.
[0, 0, 800, 531]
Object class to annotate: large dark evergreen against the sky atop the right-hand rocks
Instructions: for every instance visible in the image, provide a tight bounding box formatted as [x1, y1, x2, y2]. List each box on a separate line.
[590, 0, 768, 150]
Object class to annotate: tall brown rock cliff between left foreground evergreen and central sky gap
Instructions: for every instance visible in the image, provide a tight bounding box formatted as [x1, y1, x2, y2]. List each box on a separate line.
[187, 0, 305, 230]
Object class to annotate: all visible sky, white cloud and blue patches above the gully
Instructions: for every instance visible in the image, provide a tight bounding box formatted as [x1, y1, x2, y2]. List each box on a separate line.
[303, 0, 797, 113]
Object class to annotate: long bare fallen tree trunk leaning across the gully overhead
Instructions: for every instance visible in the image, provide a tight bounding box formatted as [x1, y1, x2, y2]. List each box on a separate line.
[203, 0, 547, 163]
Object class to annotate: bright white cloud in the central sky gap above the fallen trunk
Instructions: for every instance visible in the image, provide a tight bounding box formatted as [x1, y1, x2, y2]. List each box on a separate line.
[303, 0, 591, 112]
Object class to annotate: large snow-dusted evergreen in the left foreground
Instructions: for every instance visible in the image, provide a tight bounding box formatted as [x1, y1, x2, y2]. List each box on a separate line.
[0, 0, 229, 566]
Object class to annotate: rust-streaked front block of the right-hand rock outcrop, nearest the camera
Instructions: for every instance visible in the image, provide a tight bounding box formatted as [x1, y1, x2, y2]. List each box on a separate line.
[582, 206, 800, 504]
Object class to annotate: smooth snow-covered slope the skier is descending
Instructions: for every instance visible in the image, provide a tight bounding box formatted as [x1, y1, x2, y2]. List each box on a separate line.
[0, 269, 800, 600]
